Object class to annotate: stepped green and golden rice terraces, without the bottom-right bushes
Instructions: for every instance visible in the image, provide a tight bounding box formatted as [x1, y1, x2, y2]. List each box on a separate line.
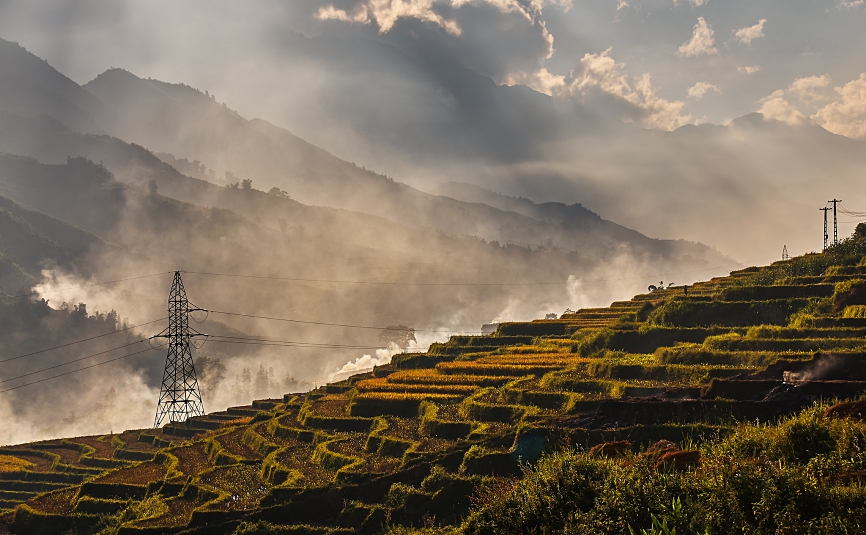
[8, 240, 866, 533]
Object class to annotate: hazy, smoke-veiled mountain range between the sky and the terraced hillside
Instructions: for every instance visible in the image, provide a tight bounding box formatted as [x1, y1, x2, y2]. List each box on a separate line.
[0, 36, 736, 440]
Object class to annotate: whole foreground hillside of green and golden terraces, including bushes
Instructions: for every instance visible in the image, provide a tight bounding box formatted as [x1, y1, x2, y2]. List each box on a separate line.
[0, 228, 866, 535]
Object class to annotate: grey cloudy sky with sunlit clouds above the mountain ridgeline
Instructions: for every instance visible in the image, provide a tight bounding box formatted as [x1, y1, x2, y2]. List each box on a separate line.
[0, 0, 866, 259]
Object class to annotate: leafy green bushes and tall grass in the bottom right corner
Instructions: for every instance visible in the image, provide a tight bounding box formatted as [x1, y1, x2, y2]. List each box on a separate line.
[463, 405, 866, 535]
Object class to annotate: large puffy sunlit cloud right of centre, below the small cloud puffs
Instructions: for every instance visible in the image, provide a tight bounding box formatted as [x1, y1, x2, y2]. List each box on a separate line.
[548, 48, 692, 130]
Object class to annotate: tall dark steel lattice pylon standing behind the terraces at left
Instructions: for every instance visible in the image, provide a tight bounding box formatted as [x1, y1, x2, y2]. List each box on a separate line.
[153, 271, 204, 427]
